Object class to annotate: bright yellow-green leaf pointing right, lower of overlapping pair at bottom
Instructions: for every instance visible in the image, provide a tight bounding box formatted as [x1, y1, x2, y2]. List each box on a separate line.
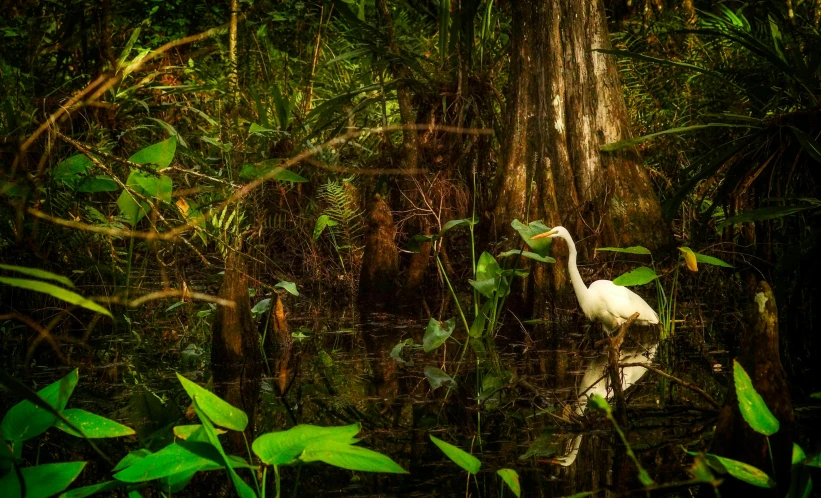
[299, 441, 407, 474]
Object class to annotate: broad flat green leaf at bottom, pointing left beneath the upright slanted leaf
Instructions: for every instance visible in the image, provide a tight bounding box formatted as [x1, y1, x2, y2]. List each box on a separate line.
[114, 441, 223, 482]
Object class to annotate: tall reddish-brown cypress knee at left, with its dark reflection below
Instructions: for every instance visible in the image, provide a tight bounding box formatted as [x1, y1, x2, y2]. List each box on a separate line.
[211, 253, 262, 452]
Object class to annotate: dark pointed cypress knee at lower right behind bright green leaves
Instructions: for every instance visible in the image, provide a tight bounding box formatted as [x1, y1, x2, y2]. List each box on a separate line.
[702, 281, 795, 498]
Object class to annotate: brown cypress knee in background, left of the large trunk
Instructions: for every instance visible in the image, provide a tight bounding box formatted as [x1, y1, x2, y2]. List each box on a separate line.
[359, 194, 399, 305]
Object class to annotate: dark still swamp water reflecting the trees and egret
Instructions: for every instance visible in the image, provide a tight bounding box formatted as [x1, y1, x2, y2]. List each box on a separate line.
[3, 300, 821, 497]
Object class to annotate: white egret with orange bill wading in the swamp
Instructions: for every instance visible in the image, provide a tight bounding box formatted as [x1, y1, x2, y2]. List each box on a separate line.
[532, 227, 659, 334]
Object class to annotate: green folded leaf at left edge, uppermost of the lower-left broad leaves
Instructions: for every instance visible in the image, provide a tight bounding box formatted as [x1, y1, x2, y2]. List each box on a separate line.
[0, 369, 79, 441]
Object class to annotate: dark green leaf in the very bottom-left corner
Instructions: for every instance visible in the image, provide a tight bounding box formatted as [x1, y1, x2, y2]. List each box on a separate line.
[0, 462, 86, 498]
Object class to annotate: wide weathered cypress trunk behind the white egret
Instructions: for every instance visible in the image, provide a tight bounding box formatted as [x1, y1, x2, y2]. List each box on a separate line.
[493, 0, 669, 312]
